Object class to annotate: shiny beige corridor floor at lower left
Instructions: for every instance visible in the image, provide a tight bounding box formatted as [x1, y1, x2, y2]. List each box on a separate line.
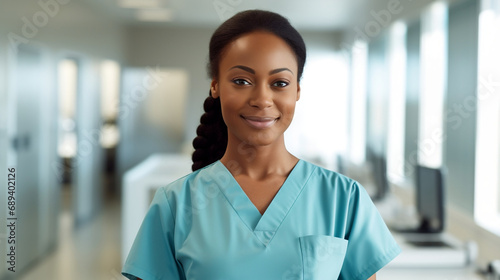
[19, 185, 125, 280]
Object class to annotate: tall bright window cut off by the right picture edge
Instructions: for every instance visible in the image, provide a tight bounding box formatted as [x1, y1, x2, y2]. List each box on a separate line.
[474, 0, 500, 235]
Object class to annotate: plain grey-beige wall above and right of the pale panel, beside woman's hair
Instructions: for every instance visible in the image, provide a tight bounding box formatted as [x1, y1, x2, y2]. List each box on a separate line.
[127, 27, 214, 149]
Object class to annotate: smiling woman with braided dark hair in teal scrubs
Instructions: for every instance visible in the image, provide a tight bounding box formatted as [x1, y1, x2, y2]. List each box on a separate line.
[123, 10, 400, 280]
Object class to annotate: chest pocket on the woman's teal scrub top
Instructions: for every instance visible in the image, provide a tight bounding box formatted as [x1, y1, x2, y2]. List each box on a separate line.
[299, 235, 348, 280]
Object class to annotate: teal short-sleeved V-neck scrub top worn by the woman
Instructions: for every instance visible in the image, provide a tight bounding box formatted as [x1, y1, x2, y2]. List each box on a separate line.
[122, 160, 401, 280]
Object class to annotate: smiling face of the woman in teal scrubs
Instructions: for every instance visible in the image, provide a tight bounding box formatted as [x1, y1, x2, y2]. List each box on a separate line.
[211, 31, 300, 146]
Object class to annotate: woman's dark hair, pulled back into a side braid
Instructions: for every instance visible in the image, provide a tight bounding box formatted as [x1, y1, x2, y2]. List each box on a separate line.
[191, 10, 306, 171]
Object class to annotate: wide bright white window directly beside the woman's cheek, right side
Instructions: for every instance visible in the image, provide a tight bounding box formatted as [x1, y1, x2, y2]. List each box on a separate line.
[285, 51, 349, 169]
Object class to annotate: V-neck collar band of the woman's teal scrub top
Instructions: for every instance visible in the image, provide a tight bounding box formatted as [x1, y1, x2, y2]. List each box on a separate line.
[208, 159, 313, 246]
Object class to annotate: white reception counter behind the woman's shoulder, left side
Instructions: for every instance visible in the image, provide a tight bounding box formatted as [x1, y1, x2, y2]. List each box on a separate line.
[122, 154, 192, 265]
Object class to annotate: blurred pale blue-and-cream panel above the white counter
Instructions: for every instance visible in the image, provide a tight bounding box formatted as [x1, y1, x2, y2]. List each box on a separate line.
[117, 67, 188, 178]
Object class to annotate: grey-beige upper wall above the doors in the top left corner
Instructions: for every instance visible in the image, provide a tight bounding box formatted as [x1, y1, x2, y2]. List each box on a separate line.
[0, 0, 124, 61]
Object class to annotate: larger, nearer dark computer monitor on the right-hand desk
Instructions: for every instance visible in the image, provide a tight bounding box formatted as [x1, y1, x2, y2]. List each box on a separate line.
[416, 165, 445, 233]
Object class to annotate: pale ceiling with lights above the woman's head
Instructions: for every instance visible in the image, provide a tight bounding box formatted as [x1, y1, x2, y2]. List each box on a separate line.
[88, 0, 373, 30]
